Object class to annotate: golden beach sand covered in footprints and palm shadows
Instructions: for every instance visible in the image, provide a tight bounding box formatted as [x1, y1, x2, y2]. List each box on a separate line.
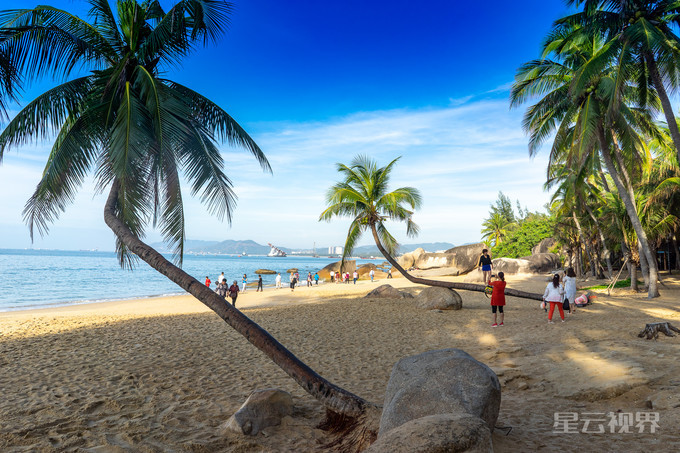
[0, 276, 680, 452]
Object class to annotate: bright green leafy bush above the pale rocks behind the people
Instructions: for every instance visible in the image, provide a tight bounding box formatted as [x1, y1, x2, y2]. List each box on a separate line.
[491, 213, 555, 258]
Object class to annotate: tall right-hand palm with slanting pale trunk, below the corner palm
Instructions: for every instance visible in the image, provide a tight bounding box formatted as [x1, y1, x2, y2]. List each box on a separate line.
[511, 23, 658, 298]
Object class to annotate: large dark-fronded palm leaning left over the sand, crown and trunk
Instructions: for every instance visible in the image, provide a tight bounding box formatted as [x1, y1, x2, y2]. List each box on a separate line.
[0, 0, 373, 418]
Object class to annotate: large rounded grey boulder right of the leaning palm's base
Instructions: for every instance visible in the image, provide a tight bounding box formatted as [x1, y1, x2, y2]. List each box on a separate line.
[378, 349, 501, 437]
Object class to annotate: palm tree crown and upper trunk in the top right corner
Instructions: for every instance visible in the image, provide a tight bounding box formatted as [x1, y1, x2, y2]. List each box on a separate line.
[556, 0, 680, 164]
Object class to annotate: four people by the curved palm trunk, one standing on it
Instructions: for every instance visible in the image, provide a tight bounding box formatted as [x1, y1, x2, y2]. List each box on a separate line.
[477, 249, 588, 327]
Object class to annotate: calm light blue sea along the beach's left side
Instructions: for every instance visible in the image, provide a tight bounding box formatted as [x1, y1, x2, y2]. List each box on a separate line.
[0, 249, 383, 311]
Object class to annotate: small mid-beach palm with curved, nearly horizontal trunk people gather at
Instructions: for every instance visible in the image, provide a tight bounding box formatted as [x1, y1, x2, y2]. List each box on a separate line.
[319, 156, 542, 300]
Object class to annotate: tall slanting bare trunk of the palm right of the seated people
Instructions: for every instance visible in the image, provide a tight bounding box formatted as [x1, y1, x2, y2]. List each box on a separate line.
[598, 126, 659, 299]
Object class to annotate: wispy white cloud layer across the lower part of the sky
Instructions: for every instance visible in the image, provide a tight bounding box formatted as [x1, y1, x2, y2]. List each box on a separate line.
[0, 96, 549, 249]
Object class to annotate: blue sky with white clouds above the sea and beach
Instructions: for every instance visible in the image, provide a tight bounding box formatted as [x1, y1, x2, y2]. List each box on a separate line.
[0, 0, 567, 250]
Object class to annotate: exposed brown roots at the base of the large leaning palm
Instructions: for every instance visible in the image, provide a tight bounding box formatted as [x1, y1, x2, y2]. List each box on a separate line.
[317, 406, 382, 453]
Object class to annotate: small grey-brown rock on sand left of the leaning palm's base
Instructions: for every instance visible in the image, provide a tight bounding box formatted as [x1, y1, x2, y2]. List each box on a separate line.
[222, 389, 293, 436]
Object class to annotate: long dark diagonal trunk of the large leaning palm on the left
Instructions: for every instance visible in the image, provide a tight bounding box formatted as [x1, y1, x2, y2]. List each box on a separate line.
[104, 180, 374, 417]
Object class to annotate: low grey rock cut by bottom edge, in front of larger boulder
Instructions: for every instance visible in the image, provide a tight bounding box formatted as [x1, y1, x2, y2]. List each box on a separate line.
[365, 413, 493, 453]
